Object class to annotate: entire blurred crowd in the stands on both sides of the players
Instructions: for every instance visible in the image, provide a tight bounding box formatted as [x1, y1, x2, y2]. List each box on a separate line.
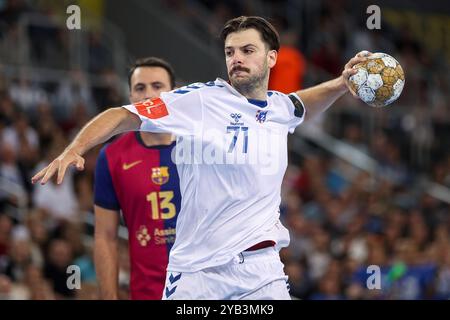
[0, 0, 450, 299]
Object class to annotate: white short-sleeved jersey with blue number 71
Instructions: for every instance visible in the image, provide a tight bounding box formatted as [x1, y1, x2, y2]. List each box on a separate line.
[125, 79, 304, 272]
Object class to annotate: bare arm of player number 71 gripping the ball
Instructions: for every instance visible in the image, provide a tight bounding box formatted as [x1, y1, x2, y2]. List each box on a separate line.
[296, 52, 367, 121]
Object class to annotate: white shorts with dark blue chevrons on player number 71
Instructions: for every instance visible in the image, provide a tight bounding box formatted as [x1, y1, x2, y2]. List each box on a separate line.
[162, 247, 291, 300]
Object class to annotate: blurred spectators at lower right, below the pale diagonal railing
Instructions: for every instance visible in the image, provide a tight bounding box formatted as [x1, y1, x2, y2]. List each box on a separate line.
[282, 153, 450, 299]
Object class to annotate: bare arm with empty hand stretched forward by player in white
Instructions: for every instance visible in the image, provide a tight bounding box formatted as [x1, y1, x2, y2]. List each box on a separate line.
[31, 107, 141, 184]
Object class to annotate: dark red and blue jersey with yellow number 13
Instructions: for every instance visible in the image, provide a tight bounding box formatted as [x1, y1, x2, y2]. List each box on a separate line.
[95, 132, 181, 299]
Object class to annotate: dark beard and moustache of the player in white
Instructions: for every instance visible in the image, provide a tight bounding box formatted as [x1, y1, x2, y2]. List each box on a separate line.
[229, 61, 269, 96]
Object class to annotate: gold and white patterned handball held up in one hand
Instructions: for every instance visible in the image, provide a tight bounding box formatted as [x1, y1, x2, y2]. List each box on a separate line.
[349, 52, 405, 107]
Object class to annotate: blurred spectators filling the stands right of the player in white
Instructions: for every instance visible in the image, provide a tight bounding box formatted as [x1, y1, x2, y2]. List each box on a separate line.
[274, 1, 450, 299]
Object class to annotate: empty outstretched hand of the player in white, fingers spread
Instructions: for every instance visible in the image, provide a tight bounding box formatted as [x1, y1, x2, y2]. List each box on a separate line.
[31, 148, 84, 184]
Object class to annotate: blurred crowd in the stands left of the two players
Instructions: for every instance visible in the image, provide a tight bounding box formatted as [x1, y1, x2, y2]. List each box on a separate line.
[0, 0, 129, 299]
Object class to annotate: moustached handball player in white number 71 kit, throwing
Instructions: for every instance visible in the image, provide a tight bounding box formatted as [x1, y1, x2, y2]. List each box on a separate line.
[32, 16, 368, 300]
